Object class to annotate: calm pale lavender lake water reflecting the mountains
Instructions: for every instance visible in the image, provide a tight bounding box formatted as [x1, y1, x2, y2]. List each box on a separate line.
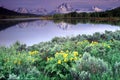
[0, 20, 120, 46]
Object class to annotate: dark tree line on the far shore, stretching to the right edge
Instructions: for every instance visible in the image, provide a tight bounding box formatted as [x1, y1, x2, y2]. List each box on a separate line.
[53, 7, 120, 19]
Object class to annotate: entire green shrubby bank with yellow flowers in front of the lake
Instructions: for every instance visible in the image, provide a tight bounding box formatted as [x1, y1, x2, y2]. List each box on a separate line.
[0, 31, 120, 80]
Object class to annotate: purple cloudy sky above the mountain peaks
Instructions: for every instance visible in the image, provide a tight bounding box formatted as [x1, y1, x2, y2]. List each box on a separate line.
[0, 0, 120, 11]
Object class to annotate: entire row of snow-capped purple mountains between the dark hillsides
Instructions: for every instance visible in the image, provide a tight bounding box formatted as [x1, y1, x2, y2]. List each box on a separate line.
[14, 3, 103, 15]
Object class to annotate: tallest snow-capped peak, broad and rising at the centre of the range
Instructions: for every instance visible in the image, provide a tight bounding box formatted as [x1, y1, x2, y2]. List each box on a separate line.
[52, 3, 74, 14]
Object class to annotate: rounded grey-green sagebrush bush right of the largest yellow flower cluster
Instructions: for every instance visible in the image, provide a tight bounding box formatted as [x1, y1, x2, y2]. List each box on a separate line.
[77, 53, 108, 74]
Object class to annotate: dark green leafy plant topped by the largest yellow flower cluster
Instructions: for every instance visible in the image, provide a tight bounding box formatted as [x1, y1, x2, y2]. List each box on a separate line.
[45, 50, 80, 80]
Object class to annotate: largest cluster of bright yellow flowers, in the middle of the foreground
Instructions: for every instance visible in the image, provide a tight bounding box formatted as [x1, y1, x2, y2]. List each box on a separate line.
[47, 50, 81, 64]
